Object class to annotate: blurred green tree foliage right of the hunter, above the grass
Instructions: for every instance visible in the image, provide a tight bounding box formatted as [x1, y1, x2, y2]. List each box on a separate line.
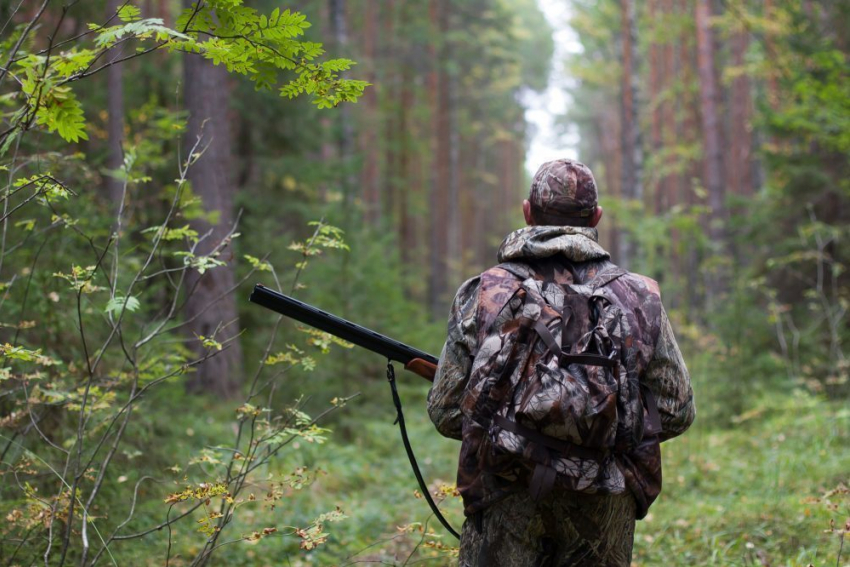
[567, 0, 850, 412]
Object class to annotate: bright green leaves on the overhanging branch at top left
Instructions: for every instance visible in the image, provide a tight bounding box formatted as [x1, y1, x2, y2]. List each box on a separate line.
[0, 0, 369, 156]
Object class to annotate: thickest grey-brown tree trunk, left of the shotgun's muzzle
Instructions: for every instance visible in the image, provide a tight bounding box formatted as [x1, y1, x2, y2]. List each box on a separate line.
[184, 21, 242, 398]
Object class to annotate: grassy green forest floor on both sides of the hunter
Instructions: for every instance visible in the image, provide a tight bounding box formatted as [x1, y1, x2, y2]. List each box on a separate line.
[136, 379, 850, 567]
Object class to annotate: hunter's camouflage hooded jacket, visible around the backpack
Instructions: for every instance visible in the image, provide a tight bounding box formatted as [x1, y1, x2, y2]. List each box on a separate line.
[428, 226, 694, 517]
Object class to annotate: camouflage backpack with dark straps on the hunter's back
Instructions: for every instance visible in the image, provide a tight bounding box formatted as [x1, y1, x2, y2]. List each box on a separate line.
[470, 264, 661, 498]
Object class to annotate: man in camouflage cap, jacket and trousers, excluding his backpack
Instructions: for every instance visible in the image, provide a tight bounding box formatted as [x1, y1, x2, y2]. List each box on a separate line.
[428, 159, 694, 567]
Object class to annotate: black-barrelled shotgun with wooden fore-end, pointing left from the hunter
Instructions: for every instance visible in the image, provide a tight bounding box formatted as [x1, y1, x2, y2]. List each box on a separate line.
[248, 284, 439, 382]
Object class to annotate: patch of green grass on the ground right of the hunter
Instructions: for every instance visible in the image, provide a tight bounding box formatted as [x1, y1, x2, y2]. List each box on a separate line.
[634, 392, 850, 567]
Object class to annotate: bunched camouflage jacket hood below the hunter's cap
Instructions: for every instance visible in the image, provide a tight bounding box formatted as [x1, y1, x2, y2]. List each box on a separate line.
[498, 226, 611, 262]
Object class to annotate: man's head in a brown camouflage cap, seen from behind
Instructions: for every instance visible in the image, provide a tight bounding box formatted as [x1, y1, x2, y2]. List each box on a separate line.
[522, 159, 602, 227]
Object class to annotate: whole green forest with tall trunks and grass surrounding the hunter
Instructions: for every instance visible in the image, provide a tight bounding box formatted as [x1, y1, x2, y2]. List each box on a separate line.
[0, 0, 850, 567]
